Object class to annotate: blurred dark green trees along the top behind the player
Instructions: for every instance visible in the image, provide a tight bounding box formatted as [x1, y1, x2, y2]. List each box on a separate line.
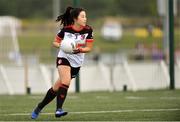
[0, 0, 167, 18]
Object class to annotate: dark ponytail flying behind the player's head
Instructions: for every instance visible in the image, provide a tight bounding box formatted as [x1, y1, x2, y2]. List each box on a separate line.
[56, 7, 74, 26]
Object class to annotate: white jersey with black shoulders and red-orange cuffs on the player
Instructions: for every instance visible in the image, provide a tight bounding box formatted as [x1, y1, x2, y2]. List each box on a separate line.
[55, 25, 93, 67]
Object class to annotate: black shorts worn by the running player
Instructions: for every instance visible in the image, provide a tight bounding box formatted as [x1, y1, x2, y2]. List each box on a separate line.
[56, 57, 80, 78]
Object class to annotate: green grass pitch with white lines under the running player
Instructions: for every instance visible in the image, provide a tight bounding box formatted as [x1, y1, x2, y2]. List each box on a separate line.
[0, 90, 180, 121]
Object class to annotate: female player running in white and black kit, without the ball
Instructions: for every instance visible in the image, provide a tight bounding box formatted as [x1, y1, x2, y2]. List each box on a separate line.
[31, 7, 93, 119]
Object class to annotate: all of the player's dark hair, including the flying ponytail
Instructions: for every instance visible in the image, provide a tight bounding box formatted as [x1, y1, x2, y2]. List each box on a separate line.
[56, 7, 84, 26]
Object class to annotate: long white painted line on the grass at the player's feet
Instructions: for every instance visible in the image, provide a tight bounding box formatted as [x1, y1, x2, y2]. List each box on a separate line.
[0, 108, 180, 116]
